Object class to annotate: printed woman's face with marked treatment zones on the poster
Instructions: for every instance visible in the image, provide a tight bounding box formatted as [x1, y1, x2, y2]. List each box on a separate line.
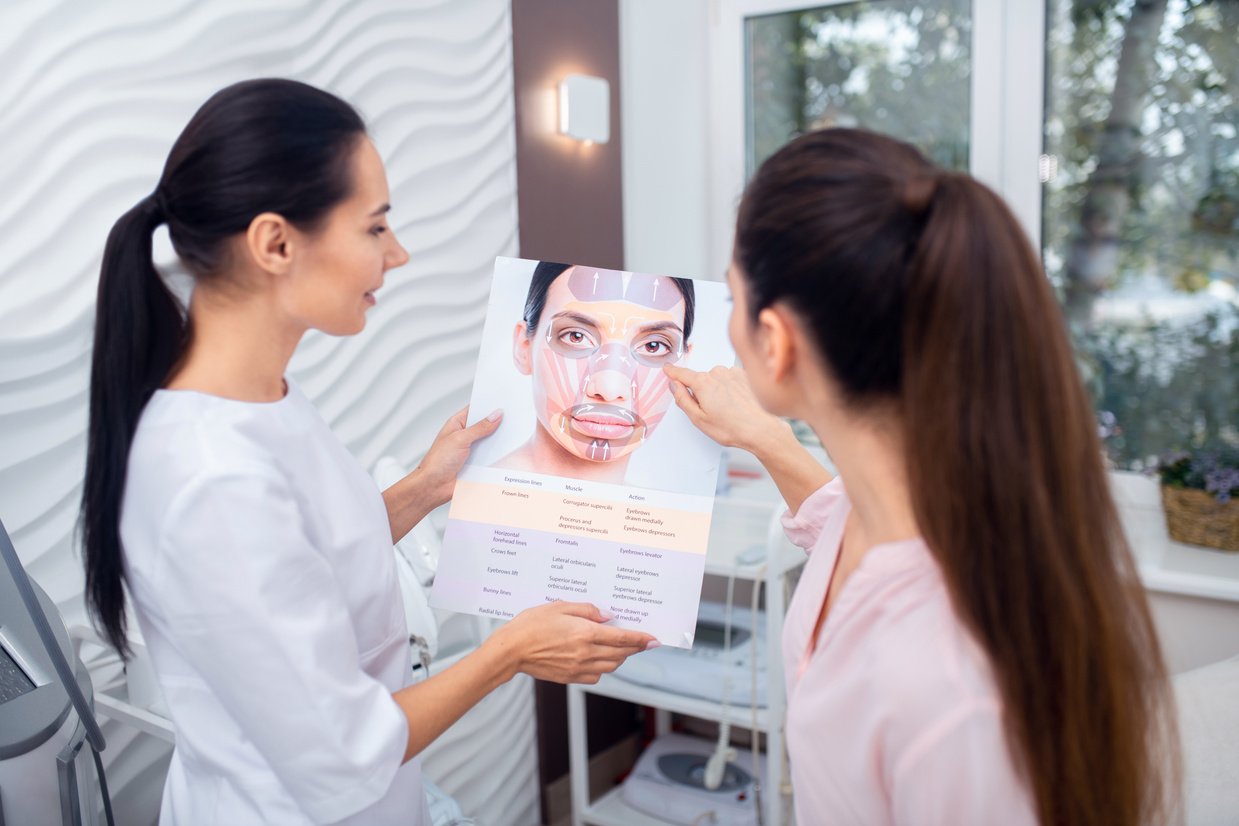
[532, 266, 685, 462]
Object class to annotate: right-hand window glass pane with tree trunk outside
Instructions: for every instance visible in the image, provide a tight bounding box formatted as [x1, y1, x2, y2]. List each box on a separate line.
[1042, 0, 1239, 469]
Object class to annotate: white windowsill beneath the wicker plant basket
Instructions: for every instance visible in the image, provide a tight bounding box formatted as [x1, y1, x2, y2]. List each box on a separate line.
[1110, 471, 1239, 602]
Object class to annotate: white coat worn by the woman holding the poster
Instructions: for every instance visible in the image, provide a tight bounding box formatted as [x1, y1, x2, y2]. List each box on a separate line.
[120, 381, 430, 826]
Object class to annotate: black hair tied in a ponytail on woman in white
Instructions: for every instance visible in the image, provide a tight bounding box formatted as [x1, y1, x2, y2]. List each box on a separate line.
[81, 79, 366, 656]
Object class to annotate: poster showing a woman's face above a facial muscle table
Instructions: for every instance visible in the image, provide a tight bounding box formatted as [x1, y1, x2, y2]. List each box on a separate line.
[431, 258, 735, 646]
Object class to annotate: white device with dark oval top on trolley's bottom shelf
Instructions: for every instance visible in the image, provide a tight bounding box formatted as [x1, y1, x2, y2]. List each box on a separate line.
[620, 733, 764, 826]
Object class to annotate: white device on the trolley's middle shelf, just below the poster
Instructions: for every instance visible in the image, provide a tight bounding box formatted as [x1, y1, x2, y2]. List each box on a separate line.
[615, 602, 767, 708]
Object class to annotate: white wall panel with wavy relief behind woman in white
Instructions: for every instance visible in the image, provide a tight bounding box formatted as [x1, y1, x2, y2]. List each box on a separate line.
[0, 0, 524, 824]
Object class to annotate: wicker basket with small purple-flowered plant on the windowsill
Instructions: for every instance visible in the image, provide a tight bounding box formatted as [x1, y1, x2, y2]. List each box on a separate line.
[1155, 446, 1239, 551]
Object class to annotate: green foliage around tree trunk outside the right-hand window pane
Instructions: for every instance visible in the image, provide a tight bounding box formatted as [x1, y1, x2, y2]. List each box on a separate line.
[1043, 0, 1239, 468]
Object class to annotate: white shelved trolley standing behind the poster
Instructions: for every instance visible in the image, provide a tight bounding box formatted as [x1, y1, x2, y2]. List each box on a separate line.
[567, 476, 805, 826]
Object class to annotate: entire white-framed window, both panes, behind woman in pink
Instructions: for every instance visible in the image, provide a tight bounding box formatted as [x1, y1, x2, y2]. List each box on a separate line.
[738, 0, 1239, 469]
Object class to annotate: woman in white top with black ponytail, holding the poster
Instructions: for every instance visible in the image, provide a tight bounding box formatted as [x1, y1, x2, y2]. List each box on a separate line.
[82, 75, 650, 824]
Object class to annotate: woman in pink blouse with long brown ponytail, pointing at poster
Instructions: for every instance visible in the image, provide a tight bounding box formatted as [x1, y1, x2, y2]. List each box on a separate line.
[667, 130, 1176, 826]
